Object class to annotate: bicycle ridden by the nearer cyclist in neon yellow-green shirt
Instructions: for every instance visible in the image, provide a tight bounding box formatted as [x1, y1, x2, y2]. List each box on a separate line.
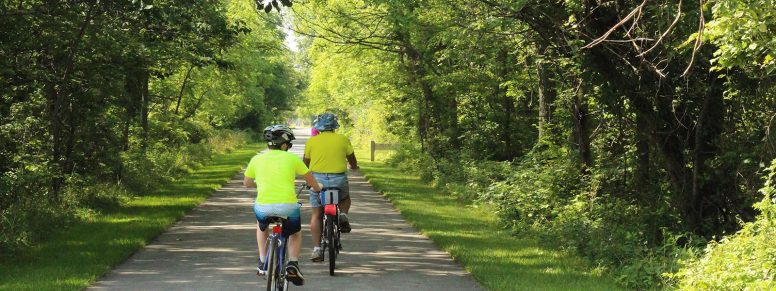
[259, 183, 310, 291]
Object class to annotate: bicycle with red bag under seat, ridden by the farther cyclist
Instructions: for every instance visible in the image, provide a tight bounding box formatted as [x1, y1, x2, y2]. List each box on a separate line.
[319, 187, 342, 276]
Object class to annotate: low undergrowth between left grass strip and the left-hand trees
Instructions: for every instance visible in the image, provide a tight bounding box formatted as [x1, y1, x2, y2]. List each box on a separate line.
[0, 130, 250, 252]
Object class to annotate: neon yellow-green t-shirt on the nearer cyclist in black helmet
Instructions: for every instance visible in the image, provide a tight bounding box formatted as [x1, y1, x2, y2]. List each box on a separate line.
[245, 150, 310, 204]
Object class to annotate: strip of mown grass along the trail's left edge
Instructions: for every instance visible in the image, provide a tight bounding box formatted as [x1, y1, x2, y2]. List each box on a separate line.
[0, 144, 259, 290]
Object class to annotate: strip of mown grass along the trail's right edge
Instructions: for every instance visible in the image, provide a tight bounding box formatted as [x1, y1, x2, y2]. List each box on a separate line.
[357, 152, 622, 290]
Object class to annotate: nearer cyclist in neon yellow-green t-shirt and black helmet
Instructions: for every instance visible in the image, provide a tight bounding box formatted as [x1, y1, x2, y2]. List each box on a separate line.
[243, 124, 321, 285]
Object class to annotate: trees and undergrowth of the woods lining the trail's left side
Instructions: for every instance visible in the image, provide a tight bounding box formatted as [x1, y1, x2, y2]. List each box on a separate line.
[0, 0, 294, 250]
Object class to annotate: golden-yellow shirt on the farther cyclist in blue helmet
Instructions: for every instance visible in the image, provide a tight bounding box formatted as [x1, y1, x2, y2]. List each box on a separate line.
[304, 131, 353, 173]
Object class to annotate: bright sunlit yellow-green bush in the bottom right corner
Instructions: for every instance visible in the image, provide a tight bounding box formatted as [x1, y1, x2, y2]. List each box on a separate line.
[673, 160, 776, 290]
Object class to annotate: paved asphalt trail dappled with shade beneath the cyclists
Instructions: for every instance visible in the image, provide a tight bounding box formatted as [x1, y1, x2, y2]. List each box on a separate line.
[88, 130, 482, 291]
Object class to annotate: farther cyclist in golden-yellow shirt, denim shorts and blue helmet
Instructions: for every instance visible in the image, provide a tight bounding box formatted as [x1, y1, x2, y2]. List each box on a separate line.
[304, 113, 358, 262]
